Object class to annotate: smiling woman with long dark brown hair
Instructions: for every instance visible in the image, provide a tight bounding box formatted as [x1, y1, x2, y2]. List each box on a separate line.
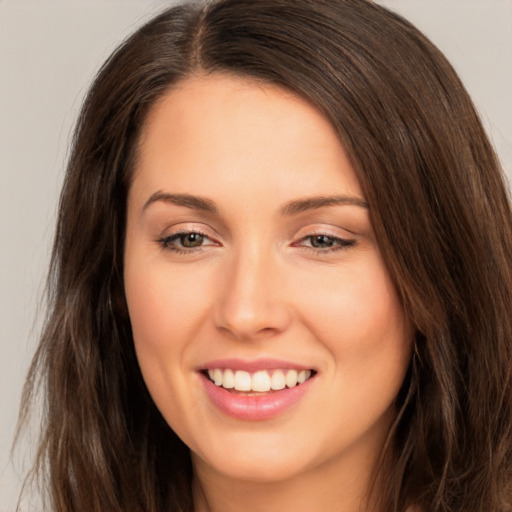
[19, 0, 512, 512]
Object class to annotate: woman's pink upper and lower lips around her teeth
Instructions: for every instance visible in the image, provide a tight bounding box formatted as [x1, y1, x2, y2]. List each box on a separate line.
[199, 359, 315, 421]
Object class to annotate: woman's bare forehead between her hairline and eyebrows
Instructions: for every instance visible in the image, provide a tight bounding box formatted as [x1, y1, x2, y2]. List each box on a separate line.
[134, 74, 360, 208]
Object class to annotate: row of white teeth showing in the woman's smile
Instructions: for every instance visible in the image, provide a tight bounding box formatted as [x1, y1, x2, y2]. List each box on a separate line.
[208, 368, 311, 393]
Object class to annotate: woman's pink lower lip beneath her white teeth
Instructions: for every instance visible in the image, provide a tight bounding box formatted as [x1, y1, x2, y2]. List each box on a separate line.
[201, 374, 315, 421]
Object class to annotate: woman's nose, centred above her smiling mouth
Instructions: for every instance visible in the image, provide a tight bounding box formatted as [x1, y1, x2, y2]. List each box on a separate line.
[214, 247, 292, 341]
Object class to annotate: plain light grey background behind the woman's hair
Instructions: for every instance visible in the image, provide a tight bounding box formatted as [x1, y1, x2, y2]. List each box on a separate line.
[0, 0, 512, 512]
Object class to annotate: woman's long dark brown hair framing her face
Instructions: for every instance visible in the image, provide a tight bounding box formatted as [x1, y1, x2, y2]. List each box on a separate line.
[18, 0, 512, 512]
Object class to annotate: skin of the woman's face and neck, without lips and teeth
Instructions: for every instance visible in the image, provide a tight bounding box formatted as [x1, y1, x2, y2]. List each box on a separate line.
[124, 74, 412, 512]
